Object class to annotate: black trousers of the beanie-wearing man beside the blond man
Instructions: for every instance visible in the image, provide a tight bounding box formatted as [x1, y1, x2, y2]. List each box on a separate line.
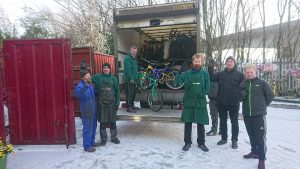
[218, 104, 240, 141]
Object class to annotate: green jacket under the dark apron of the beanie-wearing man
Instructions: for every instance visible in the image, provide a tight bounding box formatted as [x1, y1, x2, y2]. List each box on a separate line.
[92, 74, 120, 106]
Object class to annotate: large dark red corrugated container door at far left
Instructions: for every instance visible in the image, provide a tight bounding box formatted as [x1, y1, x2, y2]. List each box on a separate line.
[4, 39, 75, 144]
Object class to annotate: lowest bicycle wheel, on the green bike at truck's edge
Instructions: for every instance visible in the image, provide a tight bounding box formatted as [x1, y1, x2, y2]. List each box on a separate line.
[147, 87, 163, 111]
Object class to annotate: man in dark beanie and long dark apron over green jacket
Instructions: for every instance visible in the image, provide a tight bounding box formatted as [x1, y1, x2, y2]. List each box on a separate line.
[92, 63, 120, 146]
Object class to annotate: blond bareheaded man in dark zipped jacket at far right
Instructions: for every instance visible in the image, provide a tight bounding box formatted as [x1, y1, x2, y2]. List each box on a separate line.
[243, 64, 274, 169]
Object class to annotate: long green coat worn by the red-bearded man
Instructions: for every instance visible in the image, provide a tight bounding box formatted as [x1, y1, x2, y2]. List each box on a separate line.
[176, 69, 210, 125]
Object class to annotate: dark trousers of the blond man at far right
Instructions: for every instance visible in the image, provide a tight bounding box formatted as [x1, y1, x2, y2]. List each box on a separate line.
[244, 116, 267, 160]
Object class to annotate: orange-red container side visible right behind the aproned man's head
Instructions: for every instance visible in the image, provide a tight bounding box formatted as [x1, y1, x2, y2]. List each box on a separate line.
[94, 53, 116, 74]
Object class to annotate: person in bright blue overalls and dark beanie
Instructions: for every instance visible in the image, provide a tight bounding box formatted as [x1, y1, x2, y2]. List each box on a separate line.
[75, 66, 97, 152]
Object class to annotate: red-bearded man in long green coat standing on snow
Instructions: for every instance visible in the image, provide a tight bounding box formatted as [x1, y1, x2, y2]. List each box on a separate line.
[176, 53, 210, 152]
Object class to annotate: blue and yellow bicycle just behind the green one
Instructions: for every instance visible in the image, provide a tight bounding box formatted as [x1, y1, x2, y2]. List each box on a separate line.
[141, 59, 184, 90]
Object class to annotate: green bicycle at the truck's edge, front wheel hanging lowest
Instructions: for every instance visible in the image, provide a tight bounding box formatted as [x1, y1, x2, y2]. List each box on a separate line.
[138, 72, 163, 111]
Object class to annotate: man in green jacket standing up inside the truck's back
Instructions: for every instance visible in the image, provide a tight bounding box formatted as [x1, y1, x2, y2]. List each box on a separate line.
[123, 45, 138, 113]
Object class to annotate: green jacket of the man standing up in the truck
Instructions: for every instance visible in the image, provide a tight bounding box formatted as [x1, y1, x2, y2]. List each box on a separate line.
[123, 53, 138, 82]
